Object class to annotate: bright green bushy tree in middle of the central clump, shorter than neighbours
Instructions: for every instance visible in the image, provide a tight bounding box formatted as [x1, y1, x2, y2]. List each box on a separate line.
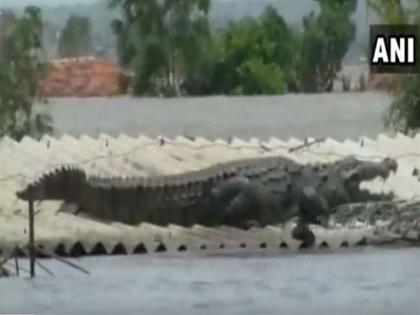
[215, 7, 297, 94]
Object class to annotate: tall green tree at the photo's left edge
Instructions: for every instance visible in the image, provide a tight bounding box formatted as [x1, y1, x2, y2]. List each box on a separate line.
[0, 6, 52, 139]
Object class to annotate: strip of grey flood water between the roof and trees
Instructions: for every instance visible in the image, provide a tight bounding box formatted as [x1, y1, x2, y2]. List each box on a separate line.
[41, 92, 391, 140]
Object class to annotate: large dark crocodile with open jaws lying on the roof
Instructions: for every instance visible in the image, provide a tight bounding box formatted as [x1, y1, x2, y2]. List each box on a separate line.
[17, 157, 397, 242]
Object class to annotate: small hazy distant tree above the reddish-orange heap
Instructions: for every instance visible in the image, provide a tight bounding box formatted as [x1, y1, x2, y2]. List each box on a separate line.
[58, 15, 92, 58]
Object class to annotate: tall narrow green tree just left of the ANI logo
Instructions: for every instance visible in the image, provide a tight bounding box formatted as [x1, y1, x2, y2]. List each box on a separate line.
[300, 0, 357, 92]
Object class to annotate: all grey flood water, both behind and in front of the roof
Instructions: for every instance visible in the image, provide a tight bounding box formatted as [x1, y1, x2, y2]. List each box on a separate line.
[10, 92, 414, 315]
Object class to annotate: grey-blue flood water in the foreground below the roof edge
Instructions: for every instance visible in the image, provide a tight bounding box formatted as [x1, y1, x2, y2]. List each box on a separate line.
[0, 247, 420, 315]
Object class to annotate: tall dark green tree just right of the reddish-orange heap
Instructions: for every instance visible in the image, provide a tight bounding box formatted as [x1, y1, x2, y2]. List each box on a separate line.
[111, 0, 210, 95]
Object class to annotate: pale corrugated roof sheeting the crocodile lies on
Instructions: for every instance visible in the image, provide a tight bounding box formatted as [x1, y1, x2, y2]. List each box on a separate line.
[0, 134, 420, 254]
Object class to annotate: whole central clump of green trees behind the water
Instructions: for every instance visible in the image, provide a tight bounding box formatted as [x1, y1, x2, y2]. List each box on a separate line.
[110, 0, 357, 96]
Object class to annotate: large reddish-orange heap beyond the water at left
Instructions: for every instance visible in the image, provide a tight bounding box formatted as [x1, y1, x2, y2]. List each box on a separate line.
[40, 57, 120, 97]
